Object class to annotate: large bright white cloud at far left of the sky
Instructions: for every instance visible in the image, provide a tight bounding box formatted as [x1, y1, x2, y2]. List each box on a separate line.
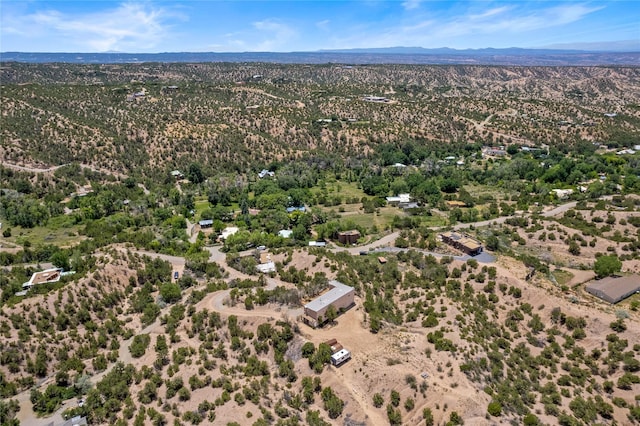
[3, 3, 185, 52]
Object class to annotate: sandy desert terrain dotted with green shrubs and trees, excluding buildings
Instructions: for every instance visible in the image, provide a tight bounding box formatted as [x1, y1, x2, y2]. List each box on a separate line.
[0, 63, 640, 425]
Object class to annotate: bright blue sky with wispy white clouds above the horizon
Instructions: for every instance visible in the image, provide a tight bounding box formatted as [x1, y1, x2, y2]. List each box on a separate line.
[0, 0, 640, 53]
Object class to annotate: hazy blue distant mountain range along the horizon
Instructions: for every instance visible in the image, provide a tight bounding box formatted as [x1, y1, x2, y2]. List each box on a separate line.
[0, 47, 640, 66]
